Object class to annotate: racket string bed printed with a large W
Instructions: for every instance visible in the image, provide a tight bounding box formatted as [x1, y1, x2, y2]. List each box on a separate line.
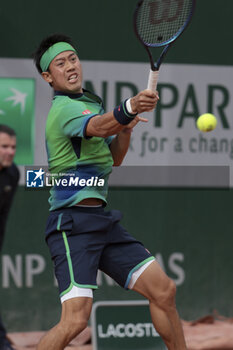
[136, 0, 193, 45]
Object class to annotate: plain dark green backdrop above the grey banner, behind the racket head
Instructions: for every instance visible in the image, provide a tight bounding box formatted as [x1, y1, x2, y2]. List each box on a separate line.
[0, 0, 233, 65]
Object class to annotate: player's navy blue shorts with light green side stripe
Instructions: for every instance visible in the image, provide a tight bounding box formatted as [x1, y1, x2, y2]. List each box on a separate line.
[46, 207, 154, 295]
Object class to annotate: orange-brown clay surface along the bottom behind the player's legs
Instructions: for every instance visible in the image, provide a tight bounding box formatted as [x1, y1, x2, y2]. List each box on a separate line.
[5, 315, 233, 350]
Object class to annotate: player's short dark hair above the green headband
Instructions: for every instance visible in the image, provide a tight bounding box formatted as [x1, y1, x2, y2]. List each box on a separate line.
[33, 34, 74, 74]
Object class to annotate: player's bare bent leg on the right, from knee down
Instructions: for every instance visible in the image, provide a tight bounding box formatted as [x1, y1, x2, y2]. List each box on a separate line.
[132, 261, 187, 350]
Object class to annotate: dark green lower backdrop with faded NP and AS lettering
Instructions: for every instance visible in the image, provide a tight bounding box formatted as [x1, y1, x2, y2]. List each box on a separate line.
[0, 187, 233, 331]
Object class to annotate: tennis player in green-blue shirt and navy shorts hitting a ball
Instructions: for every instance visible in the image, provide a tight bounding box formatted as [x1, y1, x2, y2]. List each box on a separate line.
[34, 35, 186, 350]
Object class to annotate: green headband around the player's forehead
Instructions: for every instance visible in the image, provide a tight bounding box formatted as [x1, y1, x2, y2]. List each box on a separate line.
[40, 41, 76, 72]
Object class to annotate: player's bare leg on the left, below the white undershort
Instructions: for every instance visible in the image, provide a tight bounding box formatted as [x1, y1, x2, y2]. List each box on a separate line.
[37, 297, 93, 350]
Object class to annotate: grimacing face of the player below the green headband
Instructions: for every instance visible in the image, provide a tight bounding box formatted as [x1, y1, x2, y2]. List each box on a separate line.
[42, 51, 82, 93]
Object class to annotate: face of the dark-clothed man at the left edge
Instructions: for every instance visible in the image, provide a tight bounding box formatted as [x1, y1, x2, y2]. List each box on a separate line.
[0, 132, 16, 169]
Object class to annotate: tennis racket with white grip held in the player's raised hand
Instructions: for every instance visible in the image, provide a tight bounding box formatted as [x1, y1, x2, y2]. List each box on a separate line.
[134, 0, 195, 91]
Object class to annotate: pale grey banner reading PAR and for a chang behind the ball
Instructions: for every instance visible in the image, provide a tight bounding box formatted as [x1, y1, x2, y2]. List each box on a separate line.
[84, 62, 233, 185]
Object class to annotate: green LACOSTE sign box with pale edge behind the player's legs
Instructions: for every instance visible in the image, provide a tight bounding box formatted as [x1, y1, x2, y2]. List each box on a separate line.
[91, 300, 167, 350]
